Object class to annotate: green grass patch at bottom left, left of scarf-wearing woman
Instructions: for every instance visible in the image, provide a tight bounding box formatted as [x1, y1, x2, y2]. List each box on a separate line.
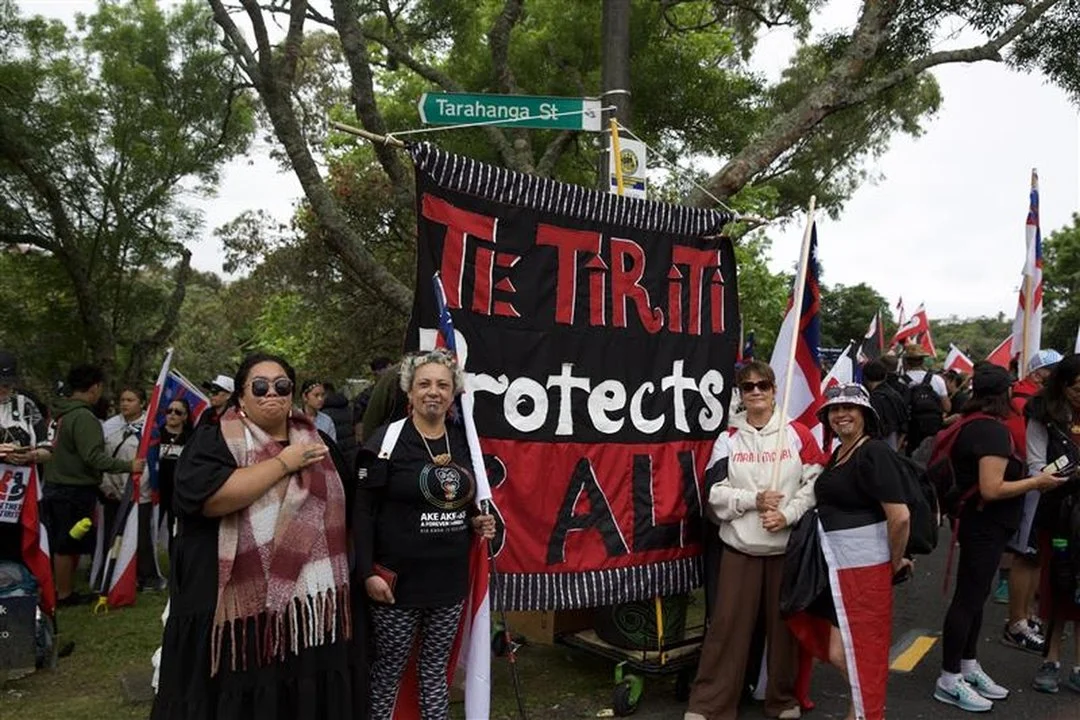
[0, 593, 166, 720]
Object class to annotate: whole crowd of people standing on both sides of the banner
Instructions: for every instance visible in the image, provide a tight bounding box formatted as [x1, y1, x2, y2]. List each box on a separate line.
[6, 338, 1080, 720]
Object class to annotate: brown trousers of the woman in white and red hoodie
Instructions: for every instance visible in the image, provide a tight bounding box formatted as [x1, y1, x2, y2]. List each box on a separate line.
[688, 547, 798, 720]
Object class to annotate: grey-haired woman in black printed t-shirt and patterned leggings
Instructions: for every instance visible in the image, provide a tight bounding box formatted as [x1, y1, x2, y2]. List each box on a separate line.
[354, 350, 495, 720]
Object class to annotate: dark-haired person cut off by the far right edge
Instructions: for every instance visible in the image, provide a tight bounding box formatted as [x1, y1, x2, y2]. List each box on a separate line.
[1026, 355, 1080, 693]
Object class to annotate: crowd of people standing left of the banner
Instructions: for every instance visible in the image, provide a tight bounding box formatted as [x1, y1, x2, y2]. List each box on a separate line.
[0, 350, 495, 720]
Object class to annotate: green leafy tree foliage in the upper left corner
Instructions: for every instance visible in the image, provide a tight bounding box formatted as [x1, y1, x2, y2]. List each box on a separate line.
[0, 0, 254, 379]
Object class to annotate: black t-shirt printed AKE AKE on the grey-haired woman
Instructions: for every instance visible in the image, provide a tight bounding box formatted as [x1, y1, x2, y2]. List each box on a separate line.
[362, 421, 476, 608]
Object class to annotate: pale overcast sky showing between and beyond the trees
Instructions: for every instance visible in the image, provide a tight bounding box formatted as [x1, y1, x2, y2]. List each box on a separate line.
[27, 0, 1080, 317]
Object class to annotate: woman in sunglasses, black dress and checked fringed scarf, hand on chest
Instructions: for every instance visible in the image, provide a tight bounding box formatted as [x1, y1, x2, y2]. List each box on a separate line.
[152, 353, 354, 720]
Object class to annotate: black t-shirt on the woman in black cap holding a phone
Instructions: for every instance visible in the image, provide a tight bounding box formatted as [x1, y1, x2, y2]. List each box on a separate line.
[951, 418, 1025, 529]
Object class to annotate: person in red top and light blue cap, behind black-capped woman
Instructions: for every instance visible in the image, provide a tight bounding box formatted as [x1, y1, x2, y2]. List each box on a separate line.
[995, 350, 1062, 655]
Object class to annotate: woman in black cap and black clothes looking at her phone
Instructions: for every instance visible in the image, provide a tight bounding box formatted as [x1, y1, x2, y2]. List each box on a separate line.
[933, 362, 1065, 712]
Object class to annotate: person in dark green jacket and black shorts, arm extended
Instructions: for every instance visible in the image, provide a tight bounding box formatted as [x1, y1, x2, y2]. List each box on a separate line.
[42, 365, 146, 606]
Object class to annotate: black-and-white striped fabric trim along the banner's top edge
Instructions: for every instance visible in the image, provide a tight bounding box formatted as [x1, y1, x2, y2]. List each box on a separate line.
[408, 142, 734, 236]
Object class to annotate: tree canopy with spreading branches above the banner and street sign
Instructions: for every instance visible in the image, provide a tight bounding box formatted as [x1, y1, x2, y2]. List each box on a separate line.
[207, 0, 1080, 314]
